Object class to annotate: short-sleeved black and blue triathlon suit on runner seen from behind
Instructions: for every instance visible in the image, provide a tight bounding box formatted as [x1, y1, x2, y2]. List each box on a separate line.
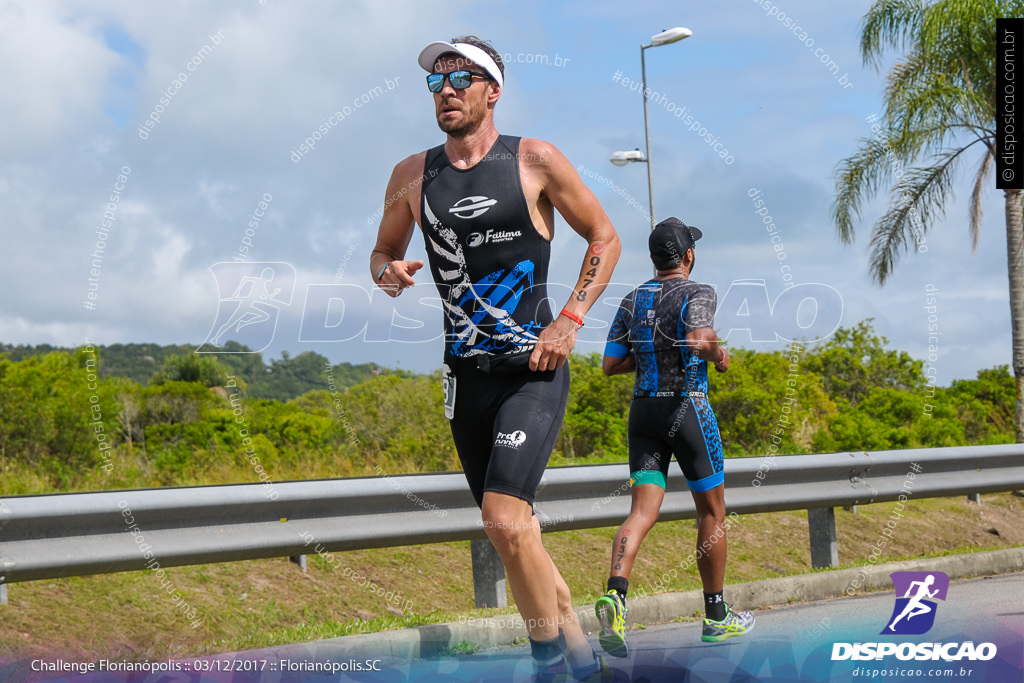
[604, 278, 725, 492]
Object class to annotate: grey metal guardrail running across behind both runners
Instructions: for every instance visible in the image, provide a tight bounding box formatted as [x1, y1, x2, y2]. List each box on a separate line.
[0, 444, 1024, 606]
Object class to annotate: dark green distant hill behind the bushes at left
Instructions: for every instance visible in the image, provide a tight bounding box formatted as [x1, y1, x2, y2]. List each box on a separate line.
[0, 341, 393, 400]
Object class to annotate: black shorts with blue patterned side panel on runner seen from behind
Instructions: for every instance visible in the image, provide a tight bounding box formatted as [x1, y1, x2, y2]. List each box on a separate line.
[630, 393, 725, 493]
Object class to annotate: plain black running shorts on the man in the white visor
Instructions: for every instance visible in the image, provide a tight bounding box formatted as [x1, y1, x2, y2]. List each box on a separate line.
[451, 361, 569, 505]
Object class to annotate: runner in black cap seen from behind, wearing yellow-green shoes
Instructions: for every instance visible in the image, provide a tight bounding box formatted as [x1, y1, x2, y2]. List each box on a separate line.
[595, 218, 754, 656]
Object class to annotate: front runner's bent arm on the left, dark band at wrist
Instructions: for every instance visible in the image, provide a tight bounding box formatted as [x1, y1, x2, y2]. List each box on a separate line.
[370, 153, 424, 297]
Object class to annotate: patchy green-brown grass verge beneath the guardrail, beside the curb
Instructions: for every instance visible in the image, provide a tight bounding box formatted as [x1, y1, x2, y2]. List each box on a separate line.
[0, 493, 1024, 661]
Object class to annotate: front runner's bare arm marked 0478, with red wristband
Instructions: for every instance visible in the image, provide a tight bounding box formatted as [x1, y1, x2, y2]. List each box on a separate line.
[520, 138, 622, 370]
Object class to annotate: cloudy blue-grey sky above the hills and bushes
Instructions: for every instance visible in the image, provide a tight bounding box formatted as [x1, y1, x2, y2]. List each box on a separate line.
[0, 0, 1011, 384]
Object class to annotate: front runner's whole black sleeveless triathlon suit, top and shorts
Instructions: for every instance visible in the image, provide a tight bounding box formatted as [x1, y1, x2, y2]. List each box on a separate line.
[420, 135, 569, 505]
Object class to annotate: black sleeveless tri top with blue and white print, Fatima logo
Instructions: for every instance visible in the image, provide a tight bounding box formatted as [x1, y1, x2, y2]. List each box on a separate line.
[421, 135, 553, 358]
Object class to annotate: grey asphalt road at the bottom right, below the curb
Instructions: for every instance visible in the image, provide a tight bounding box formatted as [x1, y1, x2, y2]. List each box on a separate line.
[593, 573, 1024, 683]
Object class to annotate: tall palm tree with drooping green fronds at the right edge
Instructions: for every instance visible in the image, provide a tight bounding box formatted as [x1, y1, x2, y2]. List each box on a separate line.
[833, 0, 1024, 442]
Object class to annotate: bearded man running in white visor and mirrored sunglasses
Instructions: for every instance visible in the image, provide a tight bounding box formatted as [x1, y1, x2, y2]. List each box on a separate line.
[370, 36, 620, 680]
